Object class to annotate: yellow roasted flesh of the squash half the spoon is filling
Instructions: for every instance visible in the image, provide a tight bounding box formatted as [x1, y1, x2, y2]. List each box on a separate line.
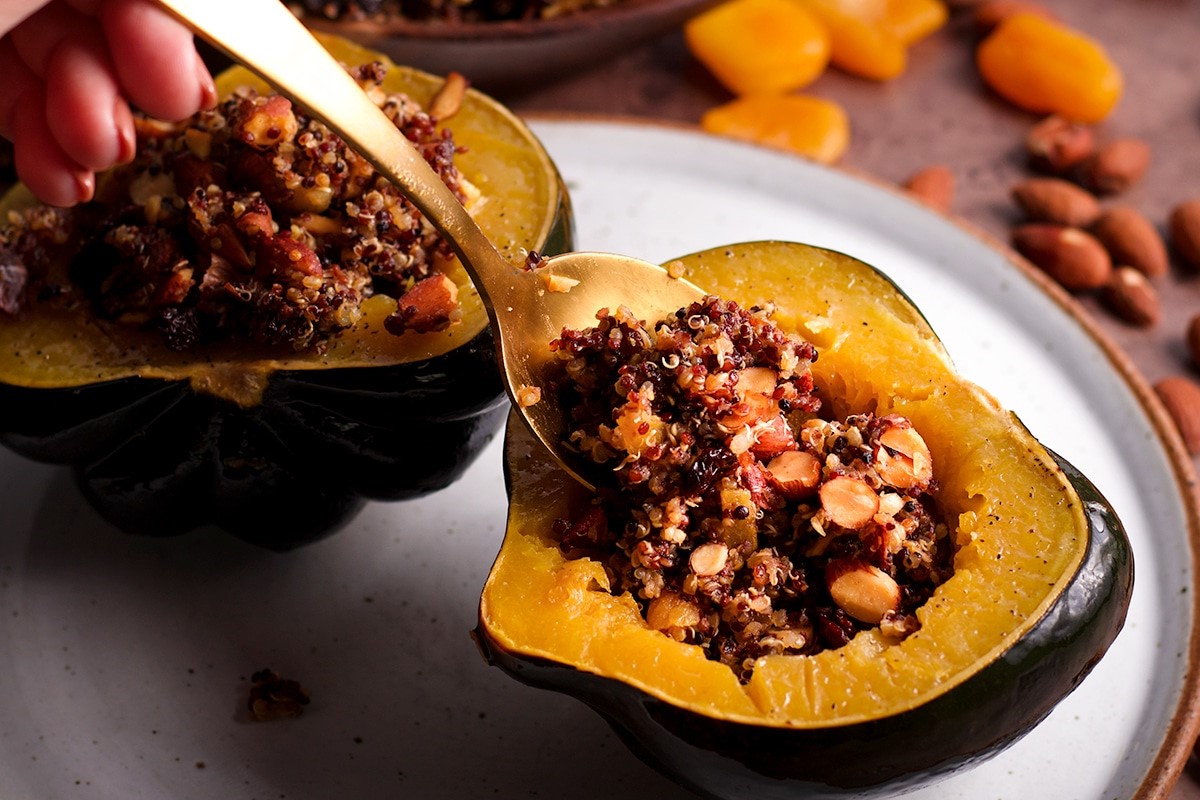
[480, 237, 1088, 728]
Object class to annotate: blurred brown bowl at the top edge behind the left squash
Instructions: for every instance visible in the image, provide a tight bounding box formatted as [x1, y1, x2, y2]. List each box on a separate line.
[302, 0, 720, 94]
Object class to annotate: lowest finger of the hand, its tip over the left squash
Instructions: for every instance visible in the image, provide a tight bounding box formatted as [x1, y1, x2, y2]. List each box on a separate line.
[12, 89, 96, 206]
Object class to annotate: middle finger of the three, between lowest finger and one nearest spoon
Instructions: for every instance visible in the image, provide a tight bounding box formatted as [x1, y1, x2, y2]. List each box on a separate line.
[44, 28, 133, 170]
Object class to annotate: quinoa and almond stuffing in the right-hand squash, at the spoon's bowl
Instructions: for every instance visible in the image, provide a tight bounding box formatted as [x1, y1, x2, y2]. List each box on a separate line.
[550, 296, 954, 680]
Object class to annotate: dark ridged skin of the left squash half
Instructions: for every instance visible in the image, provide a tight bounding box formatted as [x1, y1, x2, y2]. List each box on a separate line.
[0, 194, 575, 549]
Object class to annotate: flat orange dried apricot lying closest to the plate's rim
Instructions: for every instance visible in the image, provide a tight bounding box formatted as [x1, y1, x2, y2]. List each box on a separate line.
[700, 95, 850, 164]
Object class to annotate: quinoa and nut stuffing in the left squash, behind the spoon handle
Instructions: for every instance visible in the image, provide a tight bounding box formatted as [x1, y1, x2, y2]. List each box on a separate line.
[0, 57, 478, 351]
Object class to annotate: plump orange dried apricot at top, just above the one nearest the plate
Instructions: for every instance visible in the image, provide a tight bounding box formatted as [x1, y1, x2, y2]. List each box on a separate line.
[684, 0, 829, 95]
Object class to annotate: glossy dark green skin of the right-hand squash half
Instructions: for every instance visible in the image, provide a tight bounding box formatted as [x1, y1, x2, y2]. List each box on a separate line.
[476, 457, 1133, 800]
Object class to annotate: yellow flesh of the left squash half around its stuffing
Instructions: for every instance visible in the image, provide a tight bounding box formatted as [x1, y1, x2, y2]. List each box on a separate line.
[0, 37, 564, 405]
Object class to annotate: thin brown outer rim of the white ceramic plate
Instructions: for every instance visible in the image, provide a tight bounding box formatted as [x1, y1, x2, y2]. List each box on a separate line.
[528, 109, 1200, 800]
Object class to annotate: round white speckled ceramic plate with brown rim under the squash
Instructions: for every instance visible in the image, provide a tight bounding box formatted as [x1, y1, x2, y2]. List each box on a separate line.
[0, 119, 1198, 800]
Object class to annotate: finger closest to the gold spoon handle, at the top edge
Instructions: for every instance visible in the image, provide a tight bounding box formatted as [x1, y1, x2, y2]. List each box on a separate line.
[100, 0, 216, 120]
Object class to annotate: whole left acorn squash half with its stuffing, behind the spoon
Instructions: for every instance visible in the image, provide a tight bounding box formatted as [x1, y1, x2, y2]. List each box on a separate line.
[0, 38, 572, 548]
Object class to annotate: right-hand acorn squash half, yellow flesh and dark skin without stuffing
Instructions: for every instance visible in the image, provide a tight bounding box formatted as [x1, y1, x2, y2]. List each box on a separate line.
[476, 242, 1133, 798]
